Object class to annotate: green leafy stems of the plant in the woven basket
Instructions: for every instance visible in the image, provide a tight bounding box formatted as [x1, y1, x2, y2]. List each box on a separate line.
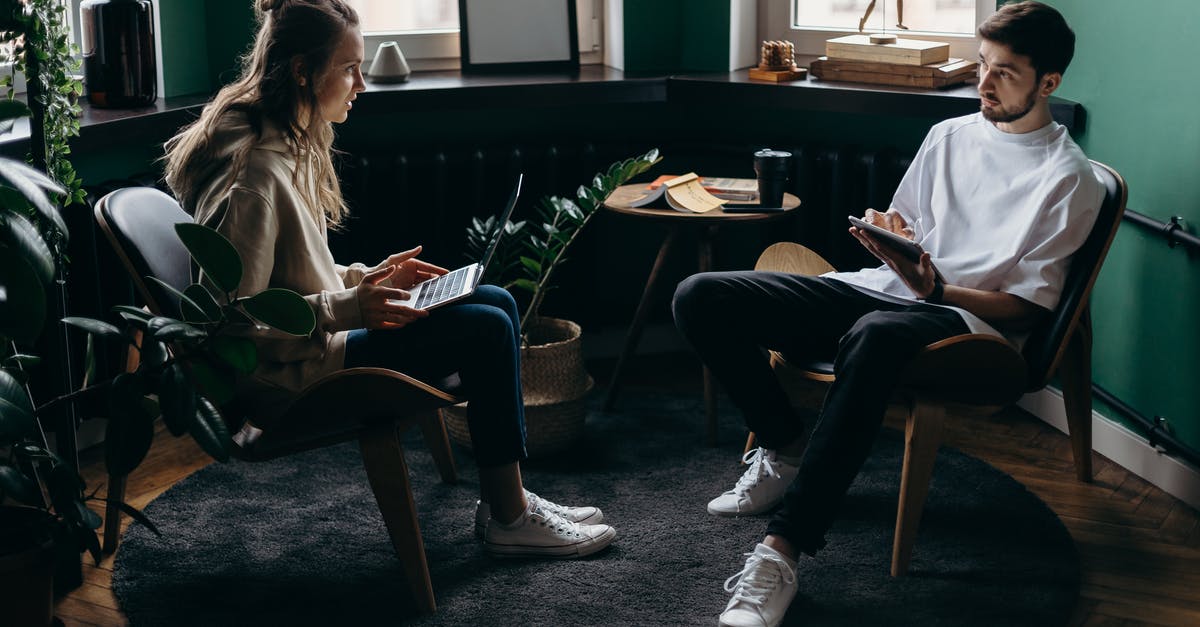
[467, 149, 661, 329]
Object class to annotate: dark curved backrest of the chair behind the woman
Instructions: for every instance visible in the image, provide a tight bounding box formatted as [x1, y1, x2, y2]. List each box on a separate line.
[96, 182, 192, 318]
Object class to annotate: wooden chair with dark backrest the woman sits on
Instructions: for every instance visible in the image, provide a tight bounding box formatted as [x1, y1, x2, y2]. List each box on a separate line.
[95, 187, 462, 613]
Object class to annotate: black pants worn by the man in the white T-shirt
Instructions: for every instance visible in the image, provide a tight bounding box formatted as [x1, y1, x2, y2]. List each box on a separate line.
[672, 271, 968, 555]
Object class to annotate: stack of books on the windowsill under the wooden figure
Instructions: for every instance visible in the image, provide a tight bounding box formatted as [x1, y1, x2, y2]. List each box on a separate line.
[809, 35, 978, 88]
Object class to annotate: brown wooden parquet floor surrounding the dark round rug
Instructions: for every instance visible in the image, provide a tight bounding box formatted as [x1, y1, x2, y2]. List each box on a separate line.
[56, 356, 1200, 627]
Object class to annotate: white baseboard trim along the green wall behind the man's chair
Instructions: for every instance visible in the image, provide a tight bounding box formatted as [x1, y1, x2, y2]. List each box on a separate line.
[1018, 388, 1200, 509]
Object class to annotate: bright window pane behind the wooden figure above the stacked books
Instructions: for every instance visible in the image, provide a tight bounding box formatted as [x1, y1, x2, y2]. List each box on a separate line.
[794, 0, 976, 35]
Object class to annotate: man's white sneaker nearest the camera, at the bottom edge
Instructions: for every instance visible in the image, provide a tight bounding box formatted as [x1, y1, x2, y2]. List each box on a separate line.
[721, 543, 798, 627]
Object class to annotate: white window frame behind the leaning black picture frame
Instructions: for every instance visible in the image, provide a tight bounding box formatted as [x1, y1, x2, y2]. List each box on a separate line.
[352, 0, 604, 72]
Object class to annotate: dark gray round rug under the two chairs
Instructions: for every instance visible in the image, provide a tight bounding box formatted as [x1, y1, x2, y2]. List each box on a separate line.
[113, 390, 1079, 626]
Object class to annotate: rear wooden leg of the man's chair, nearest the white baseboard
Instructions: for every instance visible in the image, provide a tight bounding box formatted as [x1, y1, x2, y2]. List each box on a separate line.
[1058, 314, 1092, 483]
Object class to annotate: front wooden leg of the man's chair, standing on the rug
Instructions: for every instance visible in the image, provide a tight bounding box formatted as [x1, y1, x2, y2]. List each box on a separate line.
[892, 399, 946, 577]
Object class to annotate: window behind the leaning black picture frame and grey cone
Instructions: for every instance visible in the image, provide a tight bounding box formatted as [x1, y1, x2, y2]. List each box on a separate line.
[347, 0, 601, 70]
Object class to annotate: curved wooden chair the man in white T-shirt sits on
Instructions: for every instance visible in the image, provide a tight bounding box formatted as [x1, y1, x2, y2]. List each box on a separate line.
[746, 161, 1128, 577]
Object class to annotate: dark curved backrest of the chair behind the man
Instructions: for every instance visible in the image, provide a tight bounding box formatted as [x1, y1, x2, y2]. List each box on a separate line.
[1022, 161, 1129, 390]
